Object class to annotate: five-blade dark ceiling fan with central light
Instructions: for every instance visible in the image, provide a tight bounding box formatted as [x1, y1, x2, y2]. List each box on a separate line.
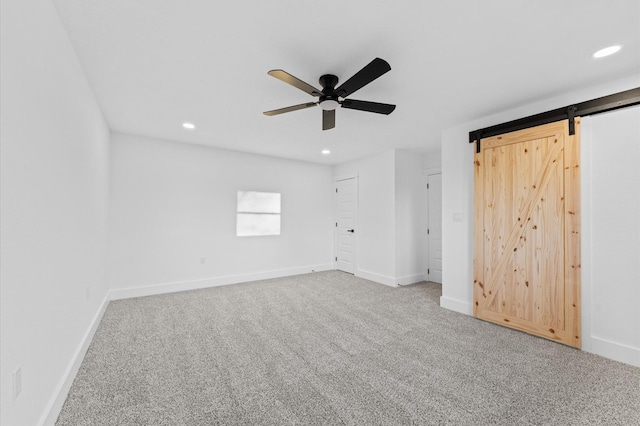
[263, 58, 396, 130]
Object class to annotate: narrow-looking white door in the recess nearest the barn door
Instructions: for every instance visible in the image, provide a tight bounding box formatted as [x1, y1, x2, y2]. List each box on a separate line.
[427, 173, 442, 283]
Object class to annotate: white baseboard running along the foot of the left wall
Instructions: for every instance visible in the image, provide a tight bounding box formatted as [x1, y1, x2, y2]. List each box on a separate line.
[38, 293, 110, 426]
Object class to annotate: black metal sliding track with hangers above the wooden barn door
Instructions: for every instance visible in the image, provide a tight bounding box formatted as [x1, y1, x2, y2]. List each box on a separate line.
[469, 87, 640, 152]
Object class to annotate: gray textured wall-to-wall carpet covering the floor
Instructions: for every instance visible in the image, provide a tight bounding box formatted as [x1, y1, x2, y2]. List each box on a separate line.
[57, 271, 640, 426]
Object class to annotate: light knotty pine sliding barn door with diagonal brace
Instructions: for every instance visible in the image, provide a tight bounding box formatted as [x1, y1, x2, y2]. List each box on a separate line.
[474, 119, 580, 347]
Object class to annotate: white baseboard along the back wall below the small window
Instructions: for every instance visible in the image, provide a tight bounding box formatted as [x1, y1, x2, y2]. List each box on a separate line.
[111, 263, 335, 300]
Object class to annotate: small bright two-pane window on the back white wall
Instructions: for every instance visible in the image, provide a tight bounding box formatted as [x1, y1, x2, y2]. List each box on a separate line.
[236, 191, 280, 237]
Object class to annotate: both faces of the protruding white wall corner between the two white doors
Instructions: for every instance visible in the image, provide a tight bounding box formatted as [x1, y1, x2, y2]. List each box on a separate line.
[333, 150, 426, 286]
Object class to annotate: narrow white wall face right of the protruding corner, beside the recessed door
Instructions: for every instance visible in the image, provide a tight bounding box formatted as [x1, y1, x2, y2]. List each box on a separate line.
[395, 150, 427, 285]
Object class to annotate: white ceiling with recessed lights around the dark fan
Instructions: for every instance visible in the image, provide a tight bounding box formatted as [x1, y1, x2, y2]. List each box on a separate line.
[53, 0, 640, 164]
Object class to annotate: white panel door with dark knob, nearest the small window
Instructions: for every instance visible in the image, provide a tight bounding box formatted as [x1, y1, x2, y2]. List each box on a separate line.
[336, 178, 358, 274]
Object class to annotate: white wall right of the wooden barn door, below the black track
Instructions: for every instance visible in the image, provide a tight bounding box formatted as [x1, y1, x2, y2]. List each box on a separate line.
[581, 107, 640, 366]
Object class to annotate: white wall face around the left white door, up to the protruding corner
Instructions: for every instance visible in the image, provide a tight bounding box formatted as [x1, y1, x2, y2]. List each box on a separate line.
[333, 150, 396, 285]
